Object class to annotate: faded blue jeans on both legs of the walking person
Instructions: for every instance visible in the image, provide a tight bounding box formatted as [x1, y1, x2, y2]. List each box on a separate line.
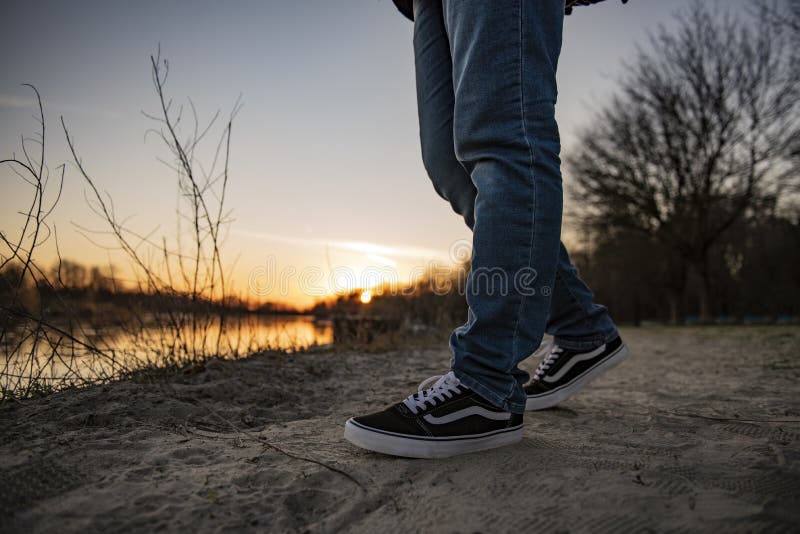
[414, 0, 617, 413]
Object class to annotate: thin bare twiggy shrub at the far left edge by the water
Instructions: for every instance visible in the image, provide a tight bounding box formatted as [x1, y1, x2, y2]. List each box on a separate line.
[0, 84, 120, 401]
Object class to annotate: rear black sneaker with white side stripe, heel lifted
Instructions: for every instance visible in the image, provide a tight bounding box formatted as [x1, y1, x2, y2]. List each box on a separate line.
[525, 336, 628, 410]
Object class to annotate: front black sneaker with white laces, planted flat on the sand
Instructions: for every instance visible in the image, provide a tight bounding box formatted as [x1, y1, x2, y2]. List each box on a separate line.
[344, 371, 522, 458]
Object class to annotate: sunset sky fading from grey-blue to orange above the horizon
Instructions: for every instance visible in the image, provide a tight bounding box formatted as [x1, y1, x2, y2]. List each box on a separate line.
[0, 0, 747, 306]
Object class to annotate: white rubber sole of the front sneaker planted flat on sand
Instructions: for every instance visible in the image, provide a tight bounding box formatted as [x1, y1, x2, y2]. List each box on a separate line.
[344, 419, 522, 458]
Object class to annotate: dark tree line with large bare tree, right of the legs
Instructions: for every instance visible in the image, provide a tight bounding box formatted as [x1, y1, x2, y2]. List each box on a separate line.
[567, 2, 800, 323]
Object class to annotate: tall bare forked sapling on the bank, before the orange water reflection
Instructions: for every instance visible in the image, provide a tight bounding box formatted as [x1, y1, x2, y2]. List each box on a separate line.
[62, 51, 241, 361]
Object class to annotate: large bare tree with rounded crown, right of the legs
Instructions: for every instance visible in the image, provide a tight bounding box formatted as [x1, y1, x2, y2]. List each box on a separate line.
[567, 1, 800, 320]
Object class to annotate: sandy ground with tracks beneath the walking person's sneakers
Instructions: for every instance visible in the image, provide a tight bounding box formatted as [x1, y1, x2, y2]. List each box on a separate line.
[0, 327, 800, 533]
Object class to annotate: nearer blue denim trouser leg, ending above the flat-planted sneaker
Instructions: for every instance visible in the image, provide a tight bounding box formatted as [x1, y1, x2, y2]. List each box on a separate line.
[442, 0, 564, 412]
